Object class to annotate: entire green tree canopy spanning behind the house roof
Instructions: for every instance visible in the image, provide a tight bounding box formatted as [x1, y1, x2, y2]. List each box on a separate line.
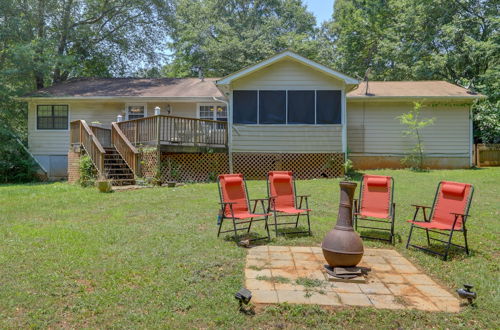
[0, 0, 500, 147]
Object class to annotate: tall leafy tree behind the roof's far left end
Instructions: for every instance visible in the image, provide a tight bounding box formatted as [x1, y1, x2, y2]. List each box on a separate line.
[0, 0, 172, 136]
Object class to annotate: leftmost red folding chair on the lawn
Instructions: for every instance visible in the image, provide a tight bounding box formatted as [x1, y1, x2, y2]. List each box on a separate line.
[217, 174, 271, 241]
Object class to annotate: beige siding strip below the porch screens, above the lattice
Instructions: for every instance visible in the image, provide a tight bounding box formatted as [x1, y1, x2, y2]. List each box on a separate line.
[233, 125, 342, 153]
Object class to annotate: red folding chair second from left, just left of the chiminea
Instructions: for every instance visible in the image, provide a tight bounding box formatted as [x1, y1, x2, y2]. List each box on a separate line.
[267, 171, 311, 236]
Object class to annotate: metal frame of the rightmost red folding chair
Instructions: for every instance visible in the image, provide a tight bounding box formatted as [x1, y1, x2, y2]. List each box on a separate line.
[406, 181, 474, 261]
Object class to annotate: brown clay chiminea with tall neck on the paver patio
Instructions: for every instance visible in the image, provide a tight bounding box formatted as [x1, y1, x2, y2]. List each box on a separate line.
[321, 181, 363, 267]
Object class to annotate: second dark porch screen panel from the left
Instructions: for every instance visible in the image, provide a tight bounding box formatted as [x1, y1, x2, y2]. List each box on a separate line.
[259, 91, 286, 124]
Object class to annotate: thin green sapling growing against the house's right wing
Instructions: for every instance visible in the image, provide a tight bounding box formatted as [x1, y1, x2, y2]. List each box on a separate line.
[396, 102, 435, 171]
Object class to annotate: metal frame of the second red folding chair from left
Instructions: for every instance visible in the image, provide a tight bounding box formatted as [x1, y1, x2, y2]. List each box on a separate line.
[267, 173, 311, 237]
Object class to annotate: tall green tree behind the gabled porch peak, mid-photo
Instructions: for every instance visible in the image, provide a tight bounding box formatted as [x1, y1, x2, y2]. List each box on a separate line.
[165, 0, 317, 76]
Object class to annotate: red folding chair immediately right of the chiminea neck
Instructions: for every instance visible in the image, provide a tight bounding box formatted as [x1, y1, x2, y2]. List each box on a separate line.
[354, 175, 396, 243]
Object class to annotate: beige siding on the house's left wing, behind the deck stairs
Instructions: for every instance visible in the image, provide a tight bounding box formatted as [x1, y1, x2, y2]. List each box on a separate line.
[28, 101, 197, 155]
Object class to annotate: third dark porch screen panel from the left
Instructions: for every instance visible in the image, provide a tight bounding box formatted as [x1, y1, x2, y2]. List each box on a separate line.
[288, 91, 314, 124]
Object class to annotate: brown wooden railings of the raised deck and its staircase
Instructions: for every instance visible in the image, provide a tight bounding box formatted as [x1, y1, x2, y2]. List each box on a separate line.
[70, 115, 227, 176]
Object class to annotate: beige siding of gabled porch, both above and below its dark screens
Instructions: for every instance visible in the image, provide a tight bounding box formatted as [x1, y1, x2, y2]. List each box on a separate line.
[231, 60, 344, 153]
